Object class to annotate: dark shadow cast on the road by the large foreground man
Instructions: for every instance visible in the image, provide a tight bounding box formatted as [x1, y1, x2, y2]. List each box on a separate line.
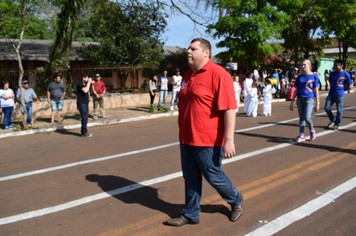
[85, 174, 230, 217]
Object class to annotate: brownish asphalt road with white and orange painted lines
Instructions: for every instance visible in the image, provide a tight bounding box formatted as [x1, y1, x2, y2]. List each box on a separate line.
[0, 93, 356, 236]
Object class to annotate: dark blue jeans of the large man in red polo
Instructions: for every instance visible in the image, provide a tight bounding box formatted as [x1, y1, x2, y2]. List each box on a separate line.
[180, 143, 242, 222]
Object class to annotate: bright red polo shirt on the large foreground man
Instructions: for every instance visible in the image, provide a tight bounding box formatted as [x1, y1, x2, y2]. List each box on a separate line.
[178, 59, 236, 147]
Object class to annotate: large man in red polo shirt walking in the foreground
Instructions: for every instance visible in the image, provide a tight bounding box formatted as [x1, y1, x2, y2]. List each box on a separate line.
[166, 38, 243, 226]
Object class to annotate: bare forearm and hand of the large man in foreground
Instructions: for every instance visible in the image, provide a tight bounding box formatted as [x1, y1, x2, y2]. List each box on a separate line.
[223, 109, 236, 158]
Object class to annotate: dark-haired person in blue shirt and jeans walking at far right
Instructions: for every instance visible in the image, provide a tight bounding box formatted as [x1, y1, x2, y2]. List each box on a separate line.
[324, 60, 352, 130]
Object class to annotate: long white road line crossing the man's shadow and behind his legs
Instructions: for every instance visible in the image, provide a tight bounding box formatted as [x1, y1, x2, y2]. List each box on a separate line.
[0, 123, 356, 226]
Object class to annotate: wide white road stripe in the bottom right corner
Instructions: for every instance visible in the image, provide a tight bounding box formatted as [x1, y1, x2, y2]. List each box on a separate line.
[246, 177, 356, 236]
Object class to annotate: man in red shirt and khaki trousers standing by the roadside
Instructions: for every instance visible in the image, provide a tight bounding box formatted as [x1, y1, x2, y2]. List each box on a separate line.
[92, 74, 106, 119]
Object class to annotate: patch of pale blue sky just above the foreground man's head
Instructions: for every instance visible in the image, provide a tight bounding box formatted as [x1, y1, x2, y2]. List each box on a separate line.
[163, 8, 224, 56]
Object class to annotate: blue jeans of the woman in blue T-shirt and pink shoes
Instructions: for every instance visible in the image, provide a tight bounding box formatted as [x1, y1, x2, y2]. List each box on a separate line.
[297, 97, 314, 136]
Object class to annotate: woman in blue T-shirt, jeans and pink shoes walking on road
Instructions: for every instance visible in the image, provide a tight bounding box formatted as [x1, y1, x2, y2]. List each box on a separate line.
[289, 60, 320, 143]
